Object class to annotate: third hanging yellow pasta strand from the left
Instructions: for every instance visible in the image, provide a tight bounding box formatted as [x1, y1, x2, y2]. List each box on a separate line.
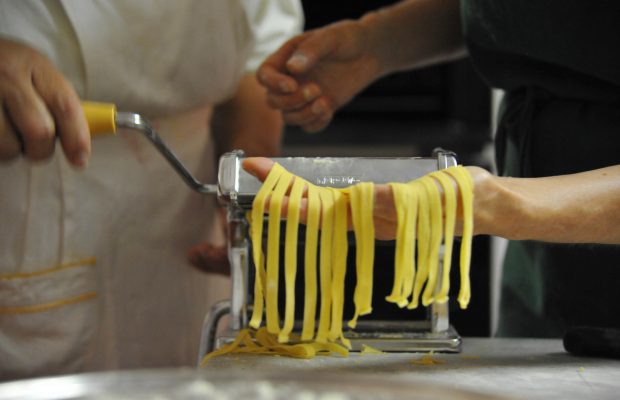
[278, 177, 306, 343]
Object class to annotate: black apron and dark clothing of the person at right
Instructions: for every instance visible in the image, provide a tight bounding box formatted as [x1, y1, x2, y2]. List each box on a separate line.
[462, 0, 620, 337]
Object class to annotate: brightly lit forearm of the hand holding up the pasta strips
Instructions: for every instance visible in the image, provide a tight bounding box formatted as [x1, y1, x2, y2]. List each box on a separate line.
[473, 165, 620, 244]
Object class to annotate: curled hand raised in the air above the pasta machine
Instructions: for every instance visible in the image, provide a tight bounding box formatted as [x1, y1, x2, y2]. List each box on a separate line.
[257, 21, 380, 132]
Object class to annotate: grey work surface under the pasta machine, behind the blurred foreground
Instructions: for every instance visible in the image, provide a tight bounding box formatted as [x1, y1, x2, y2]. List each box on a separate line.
[205, 338, 620, 400]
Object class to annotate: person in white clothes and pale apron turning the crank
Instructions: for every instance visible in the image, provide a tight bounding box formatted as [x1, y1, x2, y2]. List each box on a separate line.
[0, 0, 303, 380]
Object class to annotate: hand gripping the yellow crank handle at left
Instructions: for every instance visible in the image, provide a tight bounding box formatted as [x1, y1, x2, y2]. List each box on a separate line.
[0, 39, 90, 167]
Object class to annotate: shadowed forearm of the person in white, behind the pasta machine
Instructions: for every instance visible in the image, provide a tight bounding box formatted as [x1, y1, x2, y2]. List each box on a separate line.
[211, 74, 283, 157]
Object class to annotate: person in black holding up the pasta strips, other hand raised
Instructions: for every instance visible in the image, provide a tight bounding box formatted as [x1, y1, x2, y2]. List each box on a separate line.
[246, 0, 620, 337]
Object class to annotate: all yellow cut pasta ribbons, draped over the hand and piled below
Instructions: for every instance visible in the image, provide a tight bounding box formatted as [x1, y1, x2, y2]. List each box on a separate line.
[202, 164, 473, 364]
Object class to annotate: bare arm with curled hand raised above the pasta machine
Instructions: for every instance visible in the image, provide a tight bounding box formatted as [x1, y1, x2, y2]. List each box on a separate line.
[258, 0, 464, 131]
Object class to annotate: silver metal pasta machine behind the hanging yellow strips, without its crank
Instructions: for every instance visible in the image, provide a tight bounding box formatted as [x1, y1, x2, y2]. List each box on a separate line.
[199, 150, 461, 359]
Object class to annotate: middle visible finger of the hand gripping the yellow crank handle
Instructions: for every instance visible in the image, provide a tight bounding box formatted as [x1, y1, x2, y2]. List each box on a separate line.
[3, 85, 55, 161]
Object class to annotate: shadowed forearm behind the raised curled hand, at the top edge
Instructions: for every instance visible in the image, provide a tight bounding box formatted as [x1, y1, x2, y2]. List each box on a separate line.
[360, 0, 465, 74]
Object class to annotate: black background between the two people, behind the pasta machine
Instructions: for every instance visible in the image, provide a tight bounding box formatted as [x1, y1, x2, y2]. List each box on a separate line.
[283, 0, 491, 336]
